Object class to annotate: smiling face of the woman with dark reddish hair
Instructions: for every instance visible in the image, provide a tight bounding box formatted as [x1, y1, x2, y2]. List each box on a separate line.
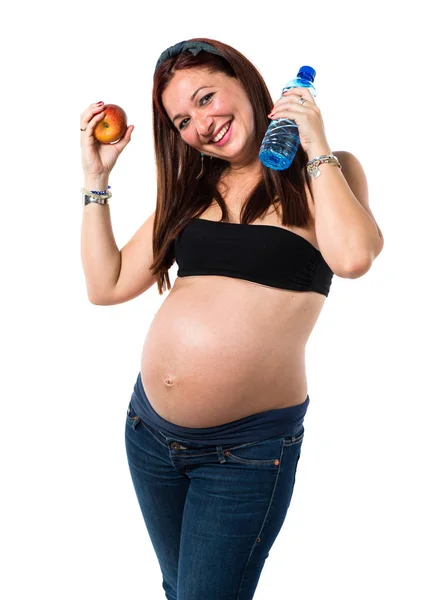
[162, 68, 257, 166]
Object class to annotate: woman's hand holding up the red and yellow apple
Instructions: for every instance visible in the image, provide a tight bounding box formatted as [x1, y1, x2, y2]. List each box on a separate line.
[80, 103, 134, 178]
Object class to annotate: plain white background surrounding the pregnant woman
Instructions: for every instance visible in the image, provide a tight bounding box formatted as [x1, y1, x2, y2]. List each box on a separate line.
[0, 0, 434, 600]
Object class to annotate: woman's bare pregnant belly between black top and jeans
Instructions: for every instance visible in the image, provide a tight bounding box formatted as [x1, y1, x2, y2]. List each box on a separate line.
[141, 276, 315, 427]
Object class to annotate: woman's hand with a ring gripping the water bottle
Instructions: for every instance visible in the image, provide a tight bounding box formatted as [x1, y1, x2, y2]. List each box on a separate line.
[268, 87, 329, 154]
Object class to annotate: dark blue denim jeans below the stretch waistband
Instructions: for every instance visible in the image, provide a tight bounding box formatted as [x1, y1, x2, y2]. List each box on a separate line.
[125, 401, 304, 600]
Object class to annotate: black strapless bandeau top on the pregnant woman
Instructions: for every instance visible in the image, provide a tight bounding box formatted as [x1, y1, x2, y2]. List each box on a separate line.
[175, 217, 333, 296]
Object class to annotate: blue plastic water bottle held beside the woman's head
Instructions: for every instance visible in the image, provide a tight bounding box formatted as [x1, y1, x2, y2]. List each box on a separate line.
[259, 66, 316, 171]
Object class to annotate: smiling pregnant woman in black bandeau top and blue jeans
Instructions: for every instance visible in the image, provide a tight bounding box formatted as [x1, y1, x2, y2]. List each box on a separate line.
[80, 38, 383, 600]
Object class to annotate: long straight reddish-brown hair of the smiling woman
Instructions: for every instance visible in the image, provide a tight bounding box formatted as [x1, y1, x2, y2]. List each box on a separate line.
[151, 38, 312, 295]
